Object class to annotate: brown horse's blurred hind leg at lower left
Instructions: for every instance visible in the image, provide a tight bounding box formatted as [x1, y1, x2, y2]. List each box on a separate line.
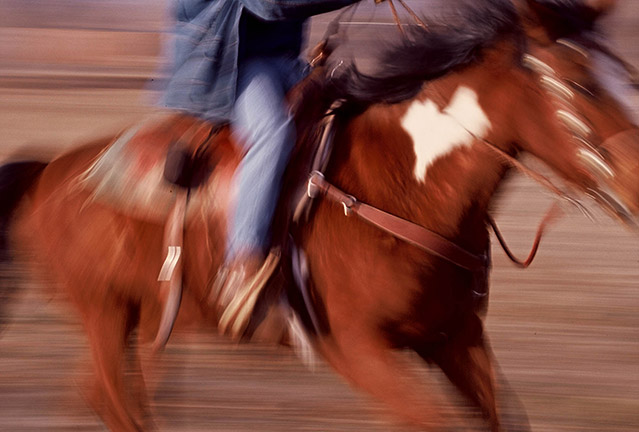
[85, 297, 144, 432]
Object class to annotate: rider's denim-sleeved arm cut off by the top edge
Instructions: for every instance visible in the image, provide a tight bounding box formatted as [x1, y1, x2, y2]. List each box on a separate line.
[240, 0, 359, 21]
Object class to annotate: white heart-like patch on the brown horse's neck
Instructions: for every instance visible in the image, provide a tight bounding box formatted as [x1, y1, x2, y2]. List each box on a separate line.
[402, 86, 491, 181]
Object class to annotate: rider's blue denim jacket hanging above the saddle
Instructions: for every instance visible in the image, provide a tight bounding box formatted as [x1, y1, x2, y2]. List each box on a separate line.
[163, 0, 359, 122]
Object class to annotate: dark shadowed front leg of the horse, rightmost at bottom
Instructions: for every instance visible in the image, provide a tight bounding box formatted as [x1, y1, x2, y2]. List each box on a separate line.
[416, 318, 502, 432]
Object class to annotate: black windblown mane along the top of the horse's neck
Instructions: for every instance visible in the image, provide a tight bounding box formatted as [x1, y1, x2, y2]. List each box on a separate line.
[327, 0, 522, 104]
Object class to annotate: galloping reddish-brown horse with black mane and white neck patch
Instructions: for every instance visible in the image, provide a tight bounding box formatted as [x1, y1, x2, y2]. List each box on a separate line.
[0, 0, 639, 431]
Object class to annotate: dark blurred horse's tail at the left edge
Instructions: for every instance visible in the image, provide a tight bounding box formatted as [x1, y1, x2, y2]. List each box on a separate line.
[0, 161, 47, 331]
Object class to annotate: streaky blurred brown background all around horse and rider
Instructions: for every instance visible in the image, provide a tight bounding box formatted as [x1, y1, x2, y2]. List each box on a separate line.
[0, 0, 639, 432]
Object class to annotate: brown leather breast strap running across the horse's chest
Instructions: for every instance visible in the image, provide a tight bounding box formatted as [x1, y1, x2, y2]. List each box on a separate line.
[308, 171, 488, 271]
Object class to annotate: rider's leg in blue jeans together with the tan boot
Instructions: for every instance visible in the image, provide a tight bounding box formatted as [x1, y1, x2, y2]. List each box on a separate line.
[220, 58, 299, 337]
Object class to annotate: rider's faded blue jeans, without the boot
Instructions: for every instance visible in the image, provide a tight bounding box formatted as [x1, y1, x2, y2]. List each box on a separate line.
[226, 57, 303, 262]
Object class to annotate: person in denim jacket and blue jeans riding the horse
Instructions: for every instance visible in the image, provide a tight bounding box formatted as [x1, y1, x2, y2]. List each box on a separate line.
[164, 0, 359, 337]
